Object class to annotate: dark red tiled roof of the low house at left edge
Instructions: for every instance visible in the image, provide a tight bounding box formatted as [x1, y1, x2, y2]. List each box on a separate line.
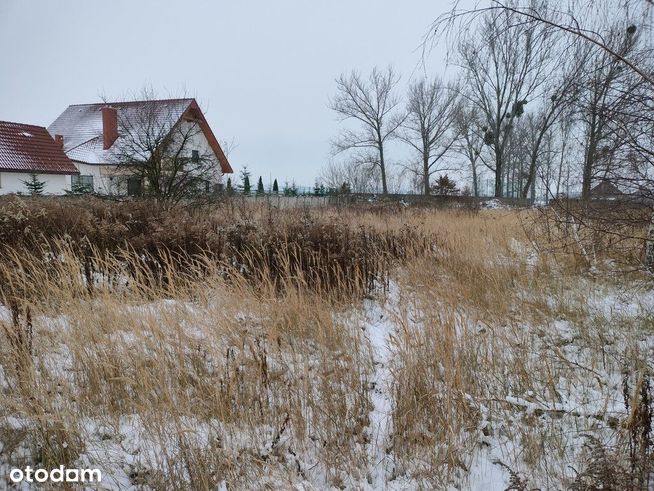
[0, 121, 78, 174]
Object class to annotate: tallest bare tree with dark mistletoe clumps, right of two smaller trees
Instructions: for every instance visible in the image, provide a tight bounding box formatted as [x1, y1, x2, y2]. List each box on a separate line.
[458, 2, 553, 197]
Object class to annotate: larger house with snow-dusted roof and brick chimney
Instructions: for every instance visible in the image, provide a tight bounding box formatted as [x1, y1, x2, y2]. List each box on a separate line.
[48, 99, 233, 195]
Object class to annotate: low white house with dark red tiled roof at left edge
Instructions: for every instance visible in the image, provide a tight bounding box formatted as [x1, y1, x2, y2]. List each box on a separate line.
[0, 121, 79, 194]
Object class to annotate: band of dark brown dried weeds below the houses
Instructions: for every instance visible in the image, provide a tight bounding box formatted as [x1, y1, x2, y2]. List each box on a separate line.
[0, 197, 438, 304]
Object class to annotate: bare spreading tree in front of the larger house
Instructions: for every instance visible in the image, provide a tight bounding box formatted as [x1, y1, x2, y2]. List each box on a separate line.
[111, 91, 222, 203]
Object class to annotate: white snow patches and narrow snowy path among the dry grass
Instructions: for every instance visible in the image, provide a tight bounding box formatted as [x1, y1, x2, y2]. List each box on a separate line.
[0, 258, 654, 491]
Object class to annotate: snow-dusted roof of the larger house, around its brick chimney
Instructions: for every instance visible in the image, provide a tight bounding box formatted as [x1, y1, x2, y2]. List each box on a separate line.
[48, 99, 233, 173]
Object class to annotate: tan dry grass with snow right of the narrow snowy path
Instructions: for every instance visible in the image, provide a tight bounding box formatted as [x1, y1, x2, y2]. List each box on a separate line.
[382, 207, 654, 489]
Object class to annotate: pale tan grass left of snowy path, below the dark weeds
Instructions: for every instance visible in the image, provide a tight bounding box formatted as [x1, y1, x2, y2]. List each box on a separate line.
[0, 251, 380, 489]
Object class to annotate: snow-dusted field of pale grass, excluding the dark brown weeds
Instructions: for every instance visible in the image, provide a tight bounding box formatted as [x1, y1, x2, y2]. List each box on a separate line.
[0, 207, 654, 491]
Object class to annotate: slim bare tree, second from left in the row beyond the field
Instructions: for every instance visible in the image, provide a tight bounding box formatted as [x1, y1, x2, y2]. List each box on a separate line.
[399, 77, 459, 195]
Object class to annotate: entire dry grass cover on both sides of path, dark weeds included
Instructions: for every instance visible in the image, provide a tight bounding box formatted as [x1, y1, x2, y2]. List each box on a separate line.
[0, 199, 654, 489]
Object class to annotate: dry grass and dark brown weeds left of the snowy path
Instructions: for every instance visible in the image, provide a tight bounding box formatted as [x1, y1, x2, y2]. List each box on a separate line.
[0, 201, 430, 489]
